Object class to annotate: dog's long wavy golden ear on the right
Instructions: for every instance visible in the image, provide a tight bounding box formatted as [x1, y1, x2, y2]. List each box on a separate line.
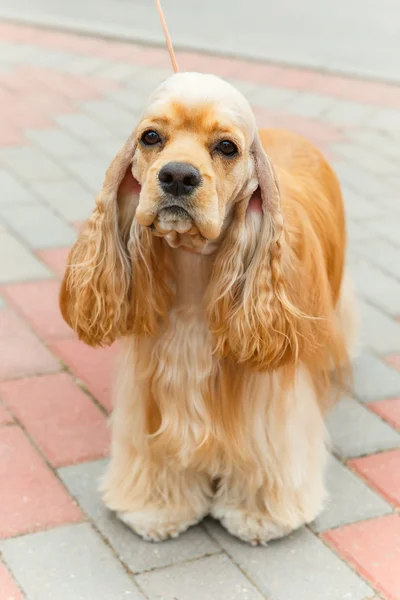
[208, 134, 310, 368]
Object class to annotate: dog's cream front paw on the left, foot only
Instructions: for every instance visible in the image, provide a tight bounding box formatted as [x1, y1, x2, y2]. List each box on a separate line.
[117, 508, 205, 542]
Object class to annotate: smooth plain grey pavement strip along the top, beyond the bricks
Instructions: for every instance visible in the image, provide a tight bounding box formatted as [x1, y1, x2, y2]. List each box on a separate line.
[0, 0, 400, 83]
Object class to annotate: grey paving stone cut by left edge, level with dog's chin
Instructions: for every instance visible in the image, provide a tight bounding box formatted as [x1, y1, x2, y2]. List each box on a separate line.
[0, 204, 77, 249]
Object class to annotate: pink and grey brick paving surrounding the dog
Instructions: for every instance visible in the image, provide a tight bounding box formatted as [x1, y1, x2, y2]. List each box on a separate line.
[0, 24, 400, 600]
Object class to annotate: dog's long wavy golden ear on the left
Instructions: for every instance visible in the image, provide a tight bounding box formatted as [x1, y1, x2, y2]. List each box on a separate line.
[60, 135, 139, 346]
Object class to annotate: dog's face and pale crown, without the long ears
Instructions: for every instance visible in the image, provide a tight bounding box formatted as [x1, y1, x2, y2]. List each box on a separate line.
[132, 73, 264, 251]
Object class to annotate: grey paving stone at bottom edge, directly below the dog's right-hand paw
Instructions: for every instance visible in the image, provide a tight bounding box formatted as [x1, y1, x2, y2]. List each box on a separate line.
[207, 521, 373, 600]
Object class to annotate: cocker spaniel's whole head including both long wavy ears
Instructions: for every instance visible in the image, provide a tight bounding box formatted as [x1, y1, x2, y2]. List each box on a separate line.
[61, 73, 293, 365]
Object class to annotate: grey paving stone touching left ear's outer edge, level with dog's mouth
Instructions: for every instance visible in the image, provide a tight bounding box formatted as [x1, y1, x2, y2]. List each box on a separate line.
[32, 179, 95, 221]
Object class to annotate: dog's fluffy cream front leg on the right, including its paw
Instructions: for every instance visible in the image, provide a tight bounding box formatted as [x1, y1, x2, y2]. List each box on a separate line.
[211, 370, 327, 545]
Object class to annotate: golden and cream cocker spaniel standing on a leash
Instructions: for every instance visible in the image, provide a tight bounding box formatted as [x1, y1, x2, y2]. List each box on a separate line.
[60, 73, 355, 545]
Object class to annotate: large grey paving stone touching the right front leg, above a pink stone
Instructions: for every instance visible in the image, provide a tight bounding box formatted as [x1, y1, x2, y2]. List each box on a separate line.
[327, 398, 400, 458]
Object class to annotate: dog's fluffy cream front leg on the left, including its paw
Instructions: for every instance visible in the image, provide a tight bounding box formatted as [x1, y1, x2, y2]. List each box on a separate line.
[102, 342, 211, 541]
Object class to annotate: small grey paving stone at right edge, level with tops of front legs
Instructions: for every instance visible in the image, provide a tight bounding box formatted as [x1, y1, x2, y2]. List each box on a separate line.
[353, 354, 400, 402]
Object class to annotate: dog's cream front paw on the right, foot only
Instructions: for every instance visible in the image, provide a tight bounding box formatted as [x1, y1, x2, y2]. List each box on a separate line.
[211, 507, 292, 546]
